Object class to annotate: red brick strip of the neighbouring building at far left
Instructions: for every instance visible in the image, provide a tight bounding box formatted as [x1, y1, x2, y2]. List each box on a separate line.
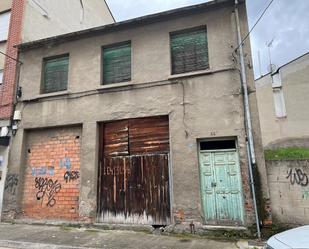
[0, 0, 25, 120]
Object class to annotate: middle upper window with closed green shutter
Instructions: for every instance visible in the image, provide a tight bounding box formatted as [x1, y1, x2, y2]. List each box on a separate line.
[103, 42, 131, 84]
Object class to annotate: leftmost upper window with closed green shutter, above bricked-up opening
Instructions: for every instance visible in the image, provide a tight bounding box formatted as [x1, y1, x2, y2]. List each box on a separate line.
[42, 55, 69, 93]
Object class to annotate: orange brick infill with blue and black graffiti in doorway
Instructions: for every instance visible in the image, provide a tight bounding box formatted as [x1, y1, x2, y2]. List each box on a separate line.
[22, 128, 81, 220]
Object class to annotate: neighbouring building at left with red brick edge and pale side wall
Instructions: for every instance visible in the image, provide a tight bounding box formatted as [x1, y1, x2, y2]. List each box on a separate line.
[0, 0, 114, 218]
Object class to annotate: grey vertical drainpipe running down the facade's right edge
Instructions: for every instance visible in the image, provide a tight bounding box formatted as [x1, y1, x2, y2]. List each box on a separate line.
[235, 0, 261, 239]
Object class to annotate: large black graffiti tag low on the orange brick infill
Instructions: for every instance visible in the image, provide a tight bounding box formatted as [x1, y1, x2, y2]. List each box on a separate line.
[35, 177, 61, 207]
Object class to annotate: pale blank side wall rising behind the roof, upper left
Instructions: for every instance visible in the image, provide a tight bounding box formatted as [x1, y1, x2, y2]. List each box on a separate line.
[22, 0, 114, 42]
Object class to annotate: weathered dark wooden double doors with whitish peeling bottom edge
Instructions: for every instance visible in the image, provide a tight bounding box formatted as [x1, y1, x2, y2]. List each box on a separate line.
[99, 154, 171, 225]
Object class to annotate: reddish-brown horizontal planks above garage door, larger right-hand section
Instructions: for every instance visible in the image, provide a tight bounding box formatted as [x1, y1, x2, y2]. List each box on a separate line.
[129, 116, 169, 155]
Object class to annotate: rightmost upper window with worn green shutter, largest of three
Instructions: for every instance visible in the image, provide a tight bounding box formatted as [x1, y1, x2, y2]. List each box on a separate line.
[170, 26, 209, 74]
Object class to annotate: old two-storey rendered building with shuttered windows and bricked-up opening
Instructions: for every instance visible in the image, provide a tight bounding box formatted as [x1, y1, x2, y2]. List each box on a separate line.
[2, 0, 268, 229]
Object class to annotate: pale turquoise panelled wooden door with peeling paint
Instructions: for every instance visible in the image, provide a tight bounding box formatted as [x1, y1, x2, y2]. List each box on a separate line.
[200, 149, 244, 225]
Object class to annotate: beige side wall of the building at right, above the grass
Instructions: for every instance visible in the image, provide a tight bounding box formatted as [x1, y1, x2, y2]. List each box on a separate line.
[256, 54, 309, 146]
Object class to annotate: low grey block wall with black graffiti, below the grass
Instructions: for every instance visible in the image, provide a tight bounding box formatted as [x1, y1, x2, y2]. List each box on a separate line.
[266, 160, 309, 225]
